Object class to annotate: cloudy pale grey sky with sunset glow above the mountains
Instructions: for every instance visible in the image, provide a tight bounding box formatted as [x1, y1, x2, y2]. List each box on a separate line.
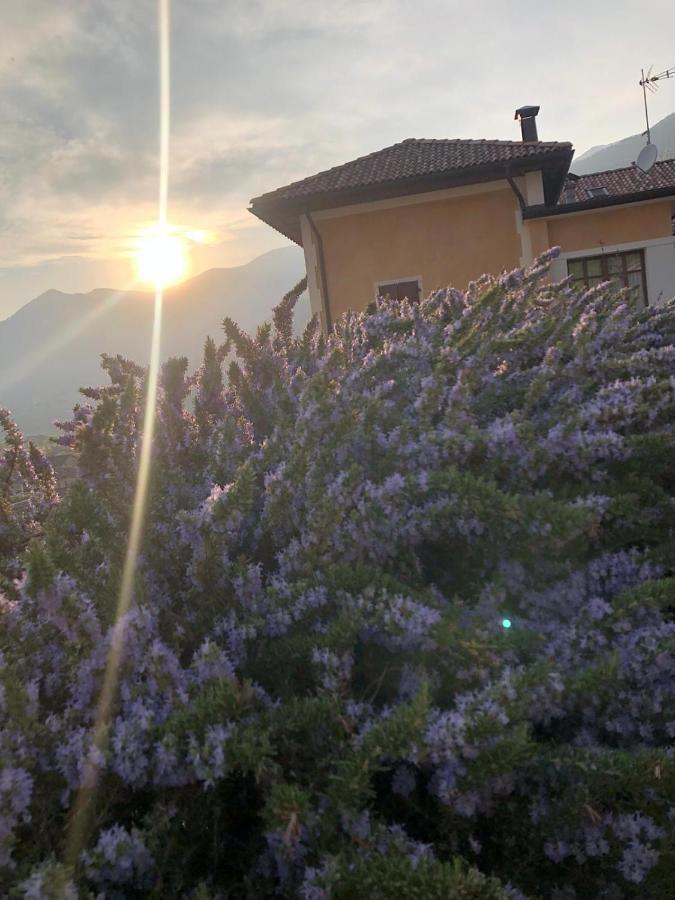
[0, 0, 675, 319]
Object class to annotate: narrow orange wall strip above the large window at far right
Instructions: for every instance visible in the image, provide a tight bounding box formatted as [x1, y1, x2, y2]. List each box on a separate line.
[548, 200, 672, 252]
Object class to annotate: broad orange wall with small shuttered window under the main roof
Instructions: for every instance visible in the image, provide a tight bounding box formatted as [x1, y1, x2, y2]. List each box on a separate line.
[315, 182, 522, 319]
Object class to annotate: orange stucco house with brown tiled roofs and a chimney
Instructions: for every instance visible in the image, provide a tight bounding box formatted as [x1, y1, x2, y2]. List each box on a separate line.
[250, 106, 675, 329]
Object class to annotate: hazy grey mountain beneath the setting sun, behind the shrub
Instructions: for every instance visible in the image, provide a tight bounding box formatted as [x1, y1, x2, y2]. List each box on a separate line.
[0, 247, 309, 434]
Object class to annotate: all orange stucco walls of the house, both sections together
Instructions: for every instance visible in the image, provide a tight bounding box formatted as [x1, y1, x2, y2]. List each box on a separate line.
[303, 185, 672, 321]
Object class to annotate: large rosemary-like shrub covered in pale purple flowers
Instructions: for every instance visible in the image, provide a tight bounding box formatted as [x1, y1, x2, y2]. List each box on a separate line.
[0, 254, 675, 900]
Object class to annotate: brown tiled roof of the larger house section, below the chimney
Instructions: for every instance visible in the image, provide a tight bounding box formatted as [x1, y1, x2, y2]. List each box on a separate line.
[251, 138, 572, 206]
